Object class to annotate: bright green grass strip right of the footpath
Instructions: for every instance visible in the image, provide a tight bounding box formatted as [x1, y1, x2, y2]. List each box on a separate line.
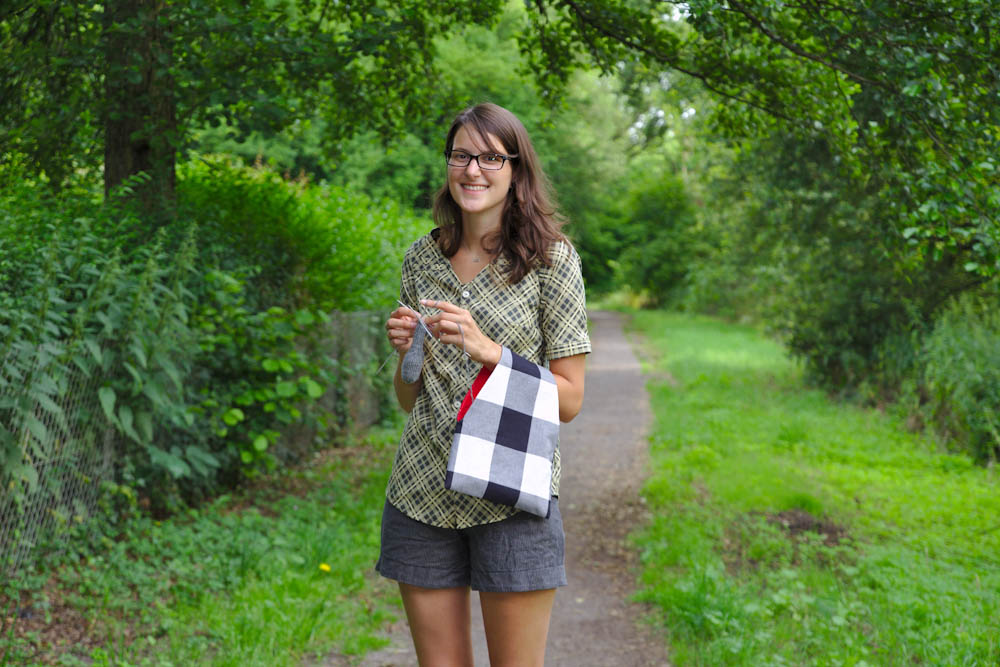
[633, 312, 1000, 667]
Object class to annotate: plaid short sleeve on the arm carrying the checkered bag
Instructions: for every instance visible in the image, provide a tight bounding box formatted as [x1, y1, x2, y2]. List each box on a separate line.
[538, 241, 591, 359]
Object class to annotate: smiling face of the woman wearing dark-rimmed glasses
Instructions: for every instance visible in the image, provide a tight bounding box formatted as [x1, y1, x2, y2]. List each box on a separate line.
[448, 126, 513, 221]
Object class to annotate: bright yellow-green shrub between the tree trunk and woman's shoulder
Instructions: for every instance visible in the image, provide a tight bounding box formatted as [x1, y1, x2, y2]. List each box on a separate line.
[178, 156, 430, 311]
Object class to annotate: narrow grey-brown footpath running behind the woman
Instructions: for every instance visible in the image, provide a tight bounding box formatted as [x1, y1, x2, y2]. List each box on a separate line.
[348, 312, 670, 667]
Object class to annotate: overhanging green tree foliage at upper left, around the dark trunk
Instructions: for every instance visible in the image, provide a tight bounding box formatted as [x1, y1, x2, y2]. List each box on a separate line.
[0, 0, 500, 222]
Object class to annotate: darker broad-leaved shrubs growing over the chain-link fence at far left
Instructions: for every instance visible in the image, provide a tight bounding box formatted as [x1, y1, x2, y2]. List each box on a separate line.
[0, 209, 322, 509]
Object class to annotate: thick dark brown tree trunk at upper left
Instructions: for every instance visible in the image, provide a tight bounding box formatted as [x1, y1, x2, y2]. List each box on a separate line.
[104, 0, 177, 226]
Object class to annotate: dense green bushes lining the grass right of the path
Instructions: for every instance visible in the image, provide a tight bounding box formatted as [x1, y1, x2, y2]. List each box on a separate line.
[605, 111, 1000, 460]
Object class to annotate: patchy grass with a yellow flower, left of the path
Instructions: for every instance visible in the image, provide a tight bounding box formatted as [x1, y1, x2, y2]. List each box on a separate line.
[0, 428, 400, 667]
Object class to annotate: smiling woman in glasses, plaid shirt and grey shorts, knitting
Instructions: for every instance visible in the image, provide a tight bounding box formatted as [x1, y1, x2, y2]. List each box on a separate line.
[377, 104, 590, 667]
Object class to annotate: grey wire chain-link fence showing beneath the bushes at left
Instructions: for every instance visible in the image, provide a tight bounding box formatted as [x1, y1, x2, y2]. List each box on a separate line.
[0, 311, 395, 577]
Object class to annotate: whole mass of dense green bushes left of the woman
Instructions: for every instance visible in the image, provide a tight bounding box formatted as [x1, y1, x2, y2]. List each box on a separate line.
[0, 160, 425, 511]
